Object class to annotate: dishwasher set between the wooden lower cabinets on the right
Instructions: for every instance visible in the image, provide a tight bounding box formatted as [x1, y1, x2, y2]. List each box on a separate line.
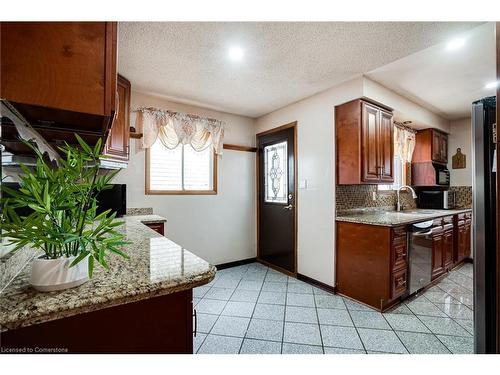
[408, 220, 441, 295]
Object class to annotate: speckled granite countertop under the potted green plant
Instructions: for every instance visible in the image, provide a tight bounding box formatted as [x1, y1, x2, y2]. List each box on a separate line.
[0, 215, 216, 331]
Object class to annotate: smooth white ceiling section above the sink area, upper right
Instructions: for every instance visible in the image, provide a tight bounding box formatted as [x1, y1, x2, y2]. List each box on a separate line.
[366, 23, 496, 120]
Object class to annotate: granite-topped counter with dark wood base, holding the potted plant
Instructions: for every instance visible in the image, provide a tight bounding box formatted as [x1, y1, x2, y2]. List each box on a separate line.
[0, 215, 216, 353]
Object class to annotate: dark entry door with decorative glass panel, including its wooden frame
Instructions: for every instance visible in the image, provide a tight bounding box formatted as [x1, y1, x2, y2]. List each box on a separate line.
[257, 123, 297, 274]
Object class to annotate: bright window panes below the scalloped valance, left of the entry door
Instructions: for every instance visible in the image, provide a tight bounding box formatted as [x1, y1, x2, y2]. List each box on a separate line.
[146, 139, 217, 194]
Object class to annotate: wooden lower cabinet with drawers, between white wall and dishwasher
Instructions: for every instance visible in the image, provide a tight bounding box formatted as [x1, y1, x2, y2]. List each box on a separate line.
[336, 222, 408, 311]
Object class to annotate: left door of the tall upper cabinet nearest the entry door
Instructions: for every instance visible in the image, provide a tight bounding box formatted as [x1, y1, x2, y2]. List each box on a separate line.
[361, 103, 381, 182]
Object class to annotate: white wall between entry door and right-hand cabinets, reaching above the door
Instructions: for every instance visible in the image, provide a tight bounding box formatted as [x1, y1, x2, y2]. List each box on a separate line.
[257, 77, 362, 286]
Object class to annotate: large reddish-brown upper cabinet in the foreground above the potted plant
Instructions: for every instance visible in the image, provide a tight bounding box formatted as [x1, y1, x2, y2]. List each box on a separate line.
[0, 22, 117, 149]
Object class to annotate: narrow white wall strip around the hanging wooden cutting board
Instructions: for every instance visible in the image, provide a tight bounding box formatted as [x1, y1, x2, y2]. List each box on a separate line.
[448, 117, 473, 186]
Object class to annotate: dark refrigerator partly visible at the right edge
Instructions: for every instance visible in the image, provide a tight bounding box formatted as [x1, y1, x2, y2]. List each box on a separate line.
[472, 96, 498, 353]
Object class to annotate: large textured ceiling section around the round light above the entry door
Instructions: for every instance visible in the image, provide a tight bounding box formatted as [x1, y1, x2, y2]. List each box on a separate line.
[119, 22, 478, 117]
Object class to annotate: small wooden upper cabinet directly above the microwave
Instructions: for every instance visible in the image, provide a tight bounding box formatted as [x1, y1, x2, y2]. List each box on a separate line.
[412, 129, 448, 164]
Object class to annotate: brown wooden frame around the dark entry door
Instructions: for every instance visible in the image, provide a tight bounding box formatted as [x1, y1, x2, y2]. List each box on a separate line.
[255, 121, 299, 277]
